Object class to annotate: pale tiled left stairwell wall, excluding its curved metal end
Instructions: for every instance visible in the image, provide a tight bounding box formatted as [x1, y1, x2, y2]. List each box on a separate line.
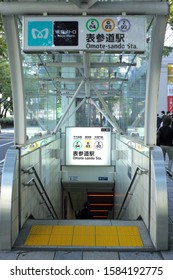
[20, 136, 62, 226]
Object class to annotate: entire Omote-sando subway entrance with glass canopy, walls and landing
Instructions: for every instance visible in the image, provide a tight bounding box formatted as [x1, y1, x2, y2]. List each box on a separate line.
[0, 0, 169, 250]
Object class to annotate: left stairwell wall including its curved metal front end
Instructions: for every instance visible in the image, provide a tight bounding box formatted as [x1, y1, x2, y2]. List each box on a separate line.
[0, 135, 62, 249]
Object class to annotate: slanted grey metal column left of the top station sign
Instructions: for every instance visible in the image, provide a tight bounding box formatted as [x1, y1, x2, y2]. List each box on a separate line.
[3, 16, 26, 145]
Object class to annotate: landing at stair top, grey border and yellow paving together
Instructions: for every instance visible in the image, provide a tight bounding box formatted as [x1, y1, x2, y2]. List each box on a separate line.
[14, 220, 154, 250]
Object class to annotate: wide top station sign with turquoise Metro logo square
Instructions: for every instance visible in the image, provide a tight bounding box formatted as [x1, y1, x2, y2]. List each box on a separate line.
[23, 16, 146, 52]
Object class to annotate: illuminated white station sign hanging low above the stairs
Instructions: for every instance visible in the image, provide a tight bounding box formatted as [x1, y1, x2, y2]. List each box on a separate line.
[66, 127, 111, 166]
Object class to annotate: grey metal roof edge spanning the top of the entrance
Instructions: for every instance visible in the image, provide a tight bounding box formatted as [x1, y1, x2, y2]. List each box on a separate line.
[0, 1, 169, 16]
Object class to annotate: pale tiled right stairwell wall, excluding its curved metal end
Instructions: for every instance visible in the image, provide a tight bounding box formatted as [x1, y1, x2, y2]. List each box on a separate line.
[115, 137, 149, 224]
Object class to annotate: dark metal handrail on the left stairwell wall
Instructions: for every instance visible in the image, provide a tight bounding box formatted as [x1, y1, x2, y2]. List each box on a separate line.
[23, 166, 58, 219]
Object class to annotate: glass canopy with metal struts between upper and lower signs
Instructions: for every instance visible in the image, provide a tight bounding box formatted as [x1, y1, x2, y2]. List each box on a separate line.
[20, 17, 152, 139]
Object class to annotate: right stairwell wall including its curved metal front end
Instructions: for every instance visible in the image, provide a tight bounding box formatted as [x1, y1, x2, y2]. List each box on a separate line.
[115, 136, 168, 250]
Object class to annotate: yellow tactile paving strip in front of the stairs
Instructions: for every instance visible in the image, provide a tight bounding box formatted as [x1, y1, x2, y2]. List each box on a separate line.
[24, 225, 143, 247]
